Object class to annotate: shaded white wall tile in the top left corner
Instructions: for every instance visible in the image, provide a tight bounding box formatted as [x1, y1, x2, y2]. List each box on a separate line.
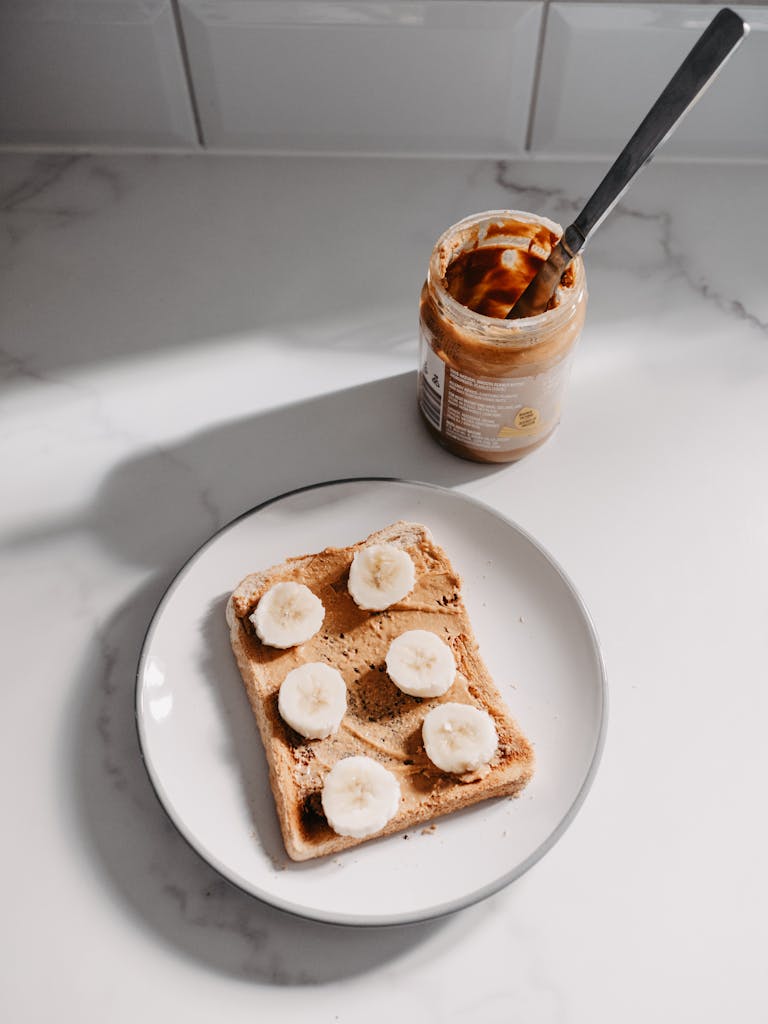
[0, 0, 197, 146]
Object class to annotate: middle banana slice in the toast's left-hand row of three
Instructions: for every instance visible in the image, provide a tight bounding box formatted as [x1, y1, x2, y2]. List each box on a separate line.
[278, 662, 347, 739]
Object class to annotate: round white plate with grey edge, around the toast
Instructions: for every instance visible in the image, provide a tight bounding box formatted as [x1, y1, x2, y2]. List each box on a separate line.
[136, 479, 605, 925]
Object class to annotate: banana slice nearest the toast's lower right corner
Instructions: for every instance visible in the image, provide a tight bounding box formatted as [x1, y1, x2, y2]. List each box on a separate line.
[421, 702, 499, 773]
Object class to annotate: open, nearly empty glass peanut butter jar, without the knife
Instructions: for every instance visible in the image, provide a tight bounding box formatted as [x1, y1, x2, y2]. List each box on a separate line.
[419, 210, 587, 462]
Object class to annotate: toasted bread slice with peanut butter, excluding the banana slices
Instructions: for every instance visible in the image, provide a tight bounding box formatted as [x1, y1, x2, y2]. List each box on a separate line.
[226, 521, 534, 860]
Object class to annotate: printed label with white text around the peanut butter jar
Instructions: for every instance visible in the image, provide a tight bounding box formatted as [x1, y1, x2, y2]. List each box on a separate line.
[419, 335, 570, 452]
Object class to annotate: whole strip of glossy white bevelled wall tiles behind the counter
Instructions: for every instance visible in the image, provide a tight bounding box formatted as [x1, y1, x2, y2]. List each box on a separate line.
[0, 0, 768, 159]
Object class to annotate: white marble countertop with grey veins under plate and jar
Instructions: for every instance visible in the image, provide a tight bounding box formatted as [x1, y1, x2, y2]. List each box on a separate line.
[0, 156, 768, 1024]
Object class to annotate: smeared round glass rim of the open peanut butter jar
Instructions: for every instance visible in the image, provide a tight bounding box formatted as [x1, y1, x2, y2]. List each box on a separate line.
[427, 210, 586, 347]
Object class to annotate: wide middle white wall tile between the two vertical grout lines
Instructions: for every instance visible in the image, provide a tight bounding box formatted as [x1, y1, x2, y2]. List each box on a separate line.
[181, 0, 542, 154]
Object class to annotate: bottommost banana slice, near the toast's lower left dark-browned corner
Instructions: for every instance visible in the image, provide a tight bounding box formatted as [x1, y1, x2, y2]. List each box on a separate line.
[322, 756, 400, 839]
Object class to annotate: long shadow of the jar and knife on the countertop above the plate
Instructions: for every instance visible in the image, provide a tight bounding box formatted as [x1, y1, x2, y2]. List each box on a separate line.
[9, 372, 507, 577]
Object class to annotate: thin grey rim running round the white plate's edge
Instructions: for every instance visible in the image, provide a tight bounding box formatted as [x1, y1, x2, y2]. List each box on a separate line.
[133, 476, 608, 928]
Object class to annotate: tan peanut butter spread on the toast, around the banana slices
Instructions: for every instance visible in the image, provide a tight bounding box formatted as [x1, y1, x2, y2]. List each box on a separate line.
[234, 543, 530, 839]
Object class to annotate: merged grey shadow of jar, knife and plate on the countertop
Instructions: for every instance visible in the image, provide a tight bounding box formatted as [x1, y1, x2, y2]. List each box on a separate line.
[63, 374, 514, 985]
